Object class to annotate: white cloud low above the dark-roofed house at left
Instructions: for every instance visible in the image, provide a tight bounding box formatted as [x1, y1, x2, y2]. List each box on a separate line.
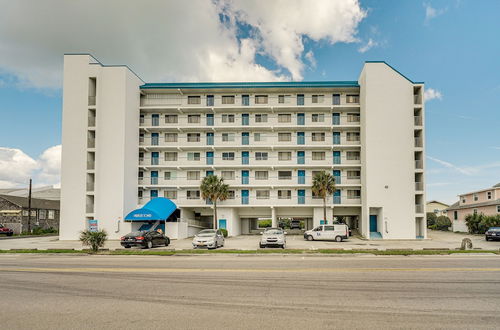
[0, 145, 61, 188]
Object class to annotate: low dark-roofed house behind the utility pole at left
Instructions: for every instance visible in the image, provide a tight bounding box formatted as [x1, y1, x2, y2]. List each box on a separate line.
[0, 195, 59, 234]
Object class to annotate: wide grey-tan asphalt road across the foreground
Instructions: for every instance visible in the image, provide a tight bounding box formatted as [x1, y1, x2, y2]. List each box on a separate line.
[0, 254, 500, 329]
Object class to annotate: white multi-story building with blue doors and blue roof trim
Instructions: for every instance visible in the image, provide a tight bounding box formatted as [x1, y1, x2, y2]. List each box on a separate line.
[61, 55, 426, 239]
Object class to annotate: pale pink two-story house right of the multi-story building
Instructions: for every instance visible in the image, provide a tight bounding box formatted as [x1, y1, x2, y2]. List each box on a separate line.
[446, 183, 500, 232]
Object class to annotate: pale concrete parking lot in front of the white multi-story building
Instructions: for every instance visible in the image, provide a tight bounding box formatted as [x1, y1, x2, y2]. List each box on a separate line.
[0, 231, 500, 252]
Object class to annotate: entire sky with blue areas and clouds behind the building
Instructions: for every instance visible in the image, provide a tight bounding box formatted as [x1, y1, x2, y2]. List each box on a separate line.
[0, 0, 500, 203]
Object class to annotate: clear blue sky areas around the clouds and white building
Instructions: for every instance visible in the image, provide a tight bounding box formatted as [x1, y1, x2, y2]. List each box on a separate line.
[0, 0, 500, 202]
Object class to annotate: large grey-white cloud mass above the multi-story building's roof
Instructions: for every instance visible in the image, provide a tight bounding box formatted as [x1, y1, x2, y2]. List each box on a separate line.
[0, 0, 366, 88]
